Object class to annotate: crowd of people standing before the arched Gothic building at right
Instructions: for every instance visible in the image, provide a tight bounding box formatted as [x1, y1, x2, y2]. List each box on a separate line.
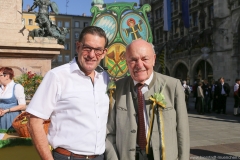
[183, 77, 240, 116]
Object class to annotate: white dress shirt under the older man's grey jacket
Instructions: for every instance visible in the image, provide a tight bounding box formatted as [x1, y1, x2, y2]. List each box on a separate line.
[133, 73, 153, 137]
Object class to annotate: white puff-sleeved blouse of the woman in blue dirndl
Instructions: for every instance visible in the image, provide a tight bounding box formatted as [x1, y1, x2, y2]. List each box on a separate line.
[0, 80, 26, 105]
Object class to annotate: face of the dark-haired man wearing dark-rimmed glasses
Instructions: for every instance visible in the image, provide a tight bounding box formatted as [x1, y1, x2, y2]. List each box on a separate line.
[76, 34, 107, 75]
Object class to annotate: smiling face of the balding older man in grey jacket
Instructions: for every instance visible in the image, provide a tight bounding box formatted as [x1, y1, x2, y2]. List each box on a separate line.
[125, 39, 156, 83]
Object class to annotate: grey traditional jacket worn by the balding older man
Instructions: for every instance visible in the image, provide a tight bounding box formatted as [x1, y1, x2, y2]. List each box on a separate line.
[105, 73, 190, 160]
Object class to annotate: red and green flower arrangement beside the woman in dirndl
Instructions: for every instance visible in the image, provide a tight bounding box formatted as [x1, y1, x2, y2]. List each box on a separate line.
[14, 71, 43, 99]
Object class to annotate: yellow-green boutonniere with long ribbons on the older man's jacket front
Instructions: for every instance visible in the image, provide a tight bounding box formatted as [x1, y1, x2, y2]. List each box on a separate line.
[146, 82, 167, 160]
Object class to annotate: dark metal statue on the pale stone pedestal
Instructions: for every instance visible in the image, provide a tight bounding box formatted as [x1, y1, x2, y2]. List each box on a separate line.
[28, 0, 69, 45]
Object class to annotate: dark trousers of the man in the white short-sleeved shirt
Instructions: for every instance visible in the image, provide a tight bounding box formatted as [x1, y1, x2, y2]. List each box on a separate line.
[52, 150, 104, 160]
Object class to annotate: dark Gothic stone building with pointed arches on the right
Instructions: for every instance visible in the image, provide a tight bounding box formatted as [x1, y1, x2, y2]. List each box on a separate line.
[140, 0, 240, 91]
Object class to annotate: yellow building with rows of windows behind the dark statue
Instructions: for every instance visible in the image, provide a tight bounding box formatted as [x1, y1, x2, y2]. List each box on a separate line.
[22, 11, 92, 68]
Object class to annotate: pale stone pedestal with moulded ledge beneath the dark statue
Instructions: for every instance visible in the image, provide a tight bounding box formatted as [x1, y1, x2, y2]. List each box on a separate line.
[0, 37, 64, 77]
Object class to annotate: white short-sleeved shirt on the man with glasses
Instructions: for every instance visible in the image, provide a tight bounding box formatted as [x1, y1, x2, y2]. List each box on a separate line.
[27, 59, 109, 155]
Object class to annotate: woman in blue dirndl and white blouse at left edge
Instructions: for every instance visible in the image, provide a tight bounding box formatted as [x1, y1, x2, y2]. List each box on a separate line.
[0, 67, 26, 130]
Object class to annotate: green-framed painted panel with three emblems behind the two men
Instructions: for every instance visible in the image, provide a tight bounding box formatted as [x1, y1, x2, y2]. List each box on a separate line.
[91, 2, 153, 78]
